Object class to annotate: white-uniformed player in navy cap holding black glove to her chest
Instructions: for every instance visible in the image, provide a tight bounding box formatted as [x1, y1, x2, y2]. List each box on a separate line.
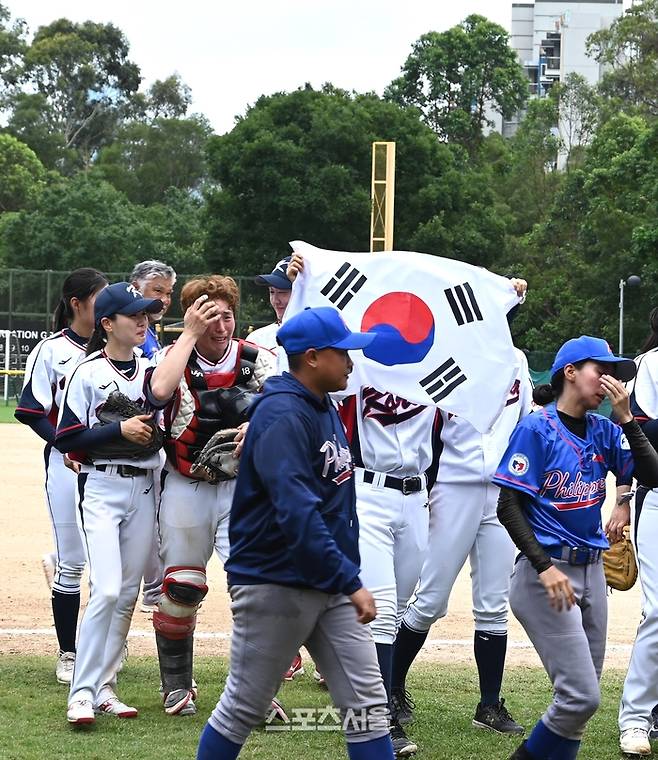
[55, 282, 167, 725]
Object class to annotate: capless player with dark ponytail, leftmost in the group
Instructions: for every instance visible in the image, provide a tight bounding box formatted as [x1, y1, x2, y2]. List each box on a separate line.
[14, 268, 107, 684]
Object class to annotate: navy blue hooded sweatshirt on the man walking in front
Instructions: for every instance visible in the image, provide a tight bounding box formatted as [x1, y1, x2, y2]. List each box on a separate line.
[225, 373, 361, 595]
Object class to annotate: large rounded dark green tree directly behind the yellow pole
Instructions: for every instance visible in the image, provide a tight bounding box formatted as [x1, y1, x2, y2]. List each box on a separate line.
[206, 85, 508, 274]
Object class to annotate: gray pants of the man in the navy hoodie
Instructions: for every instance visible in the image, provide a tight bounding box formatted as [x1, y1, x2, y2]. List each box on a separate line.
[209, 584, 388, 744]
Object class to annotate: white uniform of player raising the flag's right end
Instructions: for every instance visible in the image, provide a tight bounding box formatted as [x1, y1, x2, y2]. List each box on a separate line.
[404, 349, 532, 633]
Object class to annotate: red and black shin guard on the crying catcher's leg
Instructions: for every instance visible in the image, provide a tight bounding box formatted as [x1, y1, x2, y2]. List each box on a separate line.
[153, 567, 208, 698]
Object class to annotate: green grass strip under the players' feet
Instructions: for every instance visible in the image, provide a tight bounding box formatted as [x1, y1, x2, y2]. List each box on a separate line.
[0, 655, 623, 760]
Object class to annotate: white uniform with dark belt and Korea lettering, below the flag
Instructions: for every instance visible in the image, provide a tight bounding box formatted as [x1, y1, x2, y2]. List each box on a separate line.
[340, 387, 436, 644]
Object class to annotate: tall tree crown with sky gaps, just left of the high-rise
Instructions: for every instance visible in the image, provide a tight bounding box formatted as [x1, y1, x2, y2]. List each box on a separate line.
[384, 15, 528, 150]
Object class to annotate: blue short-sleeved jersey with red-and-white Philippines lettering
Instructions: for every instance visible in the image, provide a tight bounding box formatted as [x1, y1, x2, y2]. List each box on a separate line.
[493, 404, 634, 550]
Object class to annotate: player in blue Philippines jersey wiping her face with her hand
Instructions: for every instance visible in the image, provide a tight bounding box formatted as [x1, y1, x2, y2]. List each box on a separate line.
[493, 335, 658, 760]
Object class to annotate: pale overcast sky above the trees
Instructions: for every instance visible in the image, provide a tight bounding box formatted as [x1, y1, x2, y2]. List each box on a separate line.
[3, 0, 632, 133]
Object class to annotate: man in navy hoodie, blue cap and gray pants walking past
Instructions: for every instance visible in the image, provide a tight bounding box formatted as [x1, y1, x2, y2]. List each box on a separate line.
[197, 307, 393, 760]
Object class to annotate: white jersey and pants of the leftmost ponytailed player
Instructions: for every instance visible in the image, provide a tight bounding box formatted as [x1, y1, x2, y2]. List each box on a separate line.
[16, 328, 86, 594]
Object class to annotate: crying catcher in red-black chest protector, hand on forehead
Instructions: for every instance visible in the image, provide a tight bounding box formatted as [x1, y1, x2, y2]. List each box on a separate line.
[149, 275, 275, 715]
